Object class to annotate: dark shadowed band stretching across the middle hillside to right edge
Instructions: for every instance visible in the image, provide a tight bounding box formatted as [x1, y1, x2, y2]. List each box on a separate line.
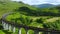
[18, 6, 60, 17]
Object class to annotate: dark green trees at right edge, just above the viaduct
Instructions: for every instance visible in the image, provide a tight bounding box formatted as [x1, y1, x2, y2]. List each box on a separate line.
[44, 20, 60, 30]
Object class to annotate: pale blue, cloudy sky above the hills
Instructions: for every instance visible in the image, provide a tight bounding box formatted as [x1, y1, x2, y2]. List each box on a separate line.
[13, 0, 60, 5]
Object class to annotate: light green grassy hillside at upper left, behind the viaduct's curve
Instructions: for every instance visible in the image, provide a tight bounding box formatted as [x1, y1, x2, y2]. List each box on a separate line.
[0, 1, 35, 18]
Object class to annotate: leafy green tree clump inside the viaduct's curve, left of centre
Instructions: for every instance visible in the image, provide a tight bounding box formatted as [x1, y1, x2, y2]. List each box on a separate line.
[15, 15, 32, 25]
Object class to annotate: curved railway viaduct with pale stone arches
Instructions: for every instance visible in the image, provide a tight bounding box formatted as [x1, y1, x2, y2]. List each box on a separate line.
[0, 14, 60, 34]
